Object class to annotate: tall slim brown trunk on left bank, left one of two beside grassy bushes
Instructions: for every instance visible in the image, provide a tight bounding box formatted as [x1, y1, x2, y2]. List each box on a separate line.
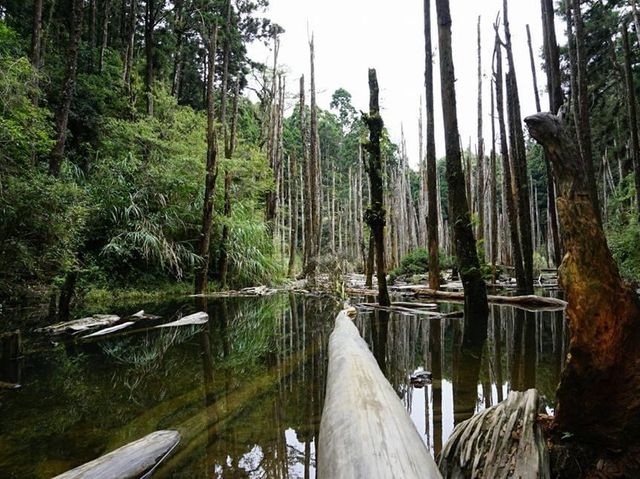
[195, 26, 218, 294]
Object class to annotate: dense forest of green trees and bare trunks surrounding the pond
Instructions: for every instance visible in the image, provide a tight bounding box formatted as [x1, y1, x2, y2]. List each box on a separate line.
[0, 0, 640, 477]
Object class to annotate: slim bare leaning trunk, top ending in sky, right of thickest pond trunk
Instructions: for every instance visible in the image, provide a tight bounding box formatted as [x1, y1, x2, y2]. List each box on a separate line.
[494, 31, 526, 290]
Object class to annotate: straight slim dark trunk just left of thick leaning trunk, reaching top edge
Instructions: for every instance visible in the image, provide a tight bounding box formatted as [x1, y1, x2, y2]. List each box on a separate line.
[424, 0, 440, 290]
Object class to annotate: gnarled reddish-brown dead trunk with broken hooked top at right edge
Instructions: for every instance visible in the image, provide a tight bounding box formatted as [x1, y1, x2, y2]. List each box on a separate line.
[525, 113, 640, 449]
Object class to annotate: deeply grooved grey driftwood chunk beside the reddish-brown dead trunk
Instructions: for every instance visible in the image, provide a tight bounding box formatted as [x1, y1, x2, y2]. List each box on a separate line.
[438, 389, 550, 479]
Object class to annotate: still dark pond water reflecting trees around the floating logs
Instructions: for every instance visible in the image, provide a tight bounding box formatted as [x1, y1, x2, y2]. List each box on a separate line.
[0, 294, 566, 478]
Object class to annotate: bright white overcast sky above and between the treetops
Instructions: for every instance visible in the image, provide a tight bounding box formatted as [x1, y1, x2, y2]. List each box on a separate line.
[249, 0, 562, 167]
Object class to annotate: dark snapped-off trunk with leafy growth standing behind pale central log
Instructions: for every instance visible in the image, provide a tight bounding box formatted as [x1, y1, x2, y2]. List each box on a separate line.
[364, 68, 391, 306]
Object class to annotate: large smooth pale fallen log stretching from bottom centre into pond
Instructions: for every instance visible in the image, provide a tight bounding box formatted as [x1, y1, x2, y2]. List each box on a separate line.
[318, 309, 441, 479]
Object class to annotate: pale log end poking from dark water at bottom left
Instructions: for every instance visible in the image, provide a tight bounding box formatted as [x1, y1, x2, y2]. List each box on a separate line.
[54, 431, 180, 479]
